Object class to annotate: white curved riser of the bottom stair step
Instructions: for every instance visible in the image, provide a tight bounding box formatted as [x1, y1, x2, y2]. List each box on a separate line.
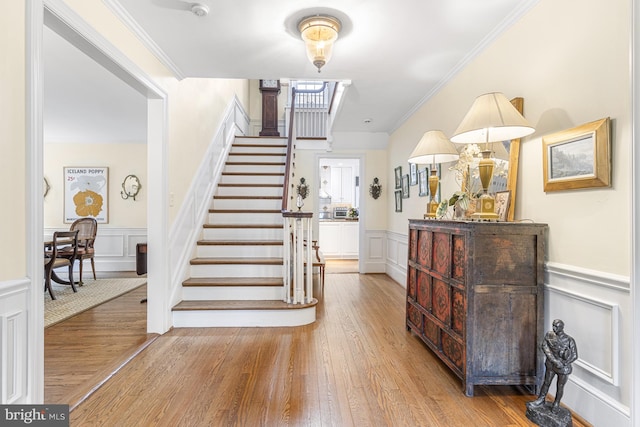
[173, 306, 316, 328]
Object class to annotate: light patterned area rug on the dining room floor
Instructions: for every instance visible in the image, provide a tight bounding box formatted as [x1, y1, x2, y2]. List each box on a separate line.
[44, 278, 147, 328]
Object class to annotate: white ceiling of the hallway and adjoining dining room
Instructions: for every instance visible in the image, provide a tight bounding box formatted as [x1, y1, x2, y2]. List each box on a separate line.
[45, 0, 537, 144]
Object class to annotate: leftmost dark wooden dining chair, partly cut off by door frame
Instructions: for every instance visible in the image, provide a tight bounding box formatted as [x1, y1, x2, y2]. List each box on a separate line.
[44, 230, 78, 299]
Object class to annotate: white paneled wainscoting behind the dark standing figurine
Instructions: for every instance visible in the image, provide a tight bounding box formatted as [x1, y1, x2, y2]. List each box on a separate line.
[545, 263, 632, 426]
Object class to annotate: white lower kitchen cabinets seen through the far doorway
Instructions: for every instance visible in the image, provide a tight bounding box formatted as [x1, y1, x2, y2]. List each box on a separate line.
[318, 220, 360, 259]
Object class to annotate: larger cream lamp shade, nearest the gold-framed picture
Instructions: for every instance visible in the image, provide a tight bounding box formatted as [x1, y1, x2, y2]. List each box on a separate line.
[451, 92, 535, 144]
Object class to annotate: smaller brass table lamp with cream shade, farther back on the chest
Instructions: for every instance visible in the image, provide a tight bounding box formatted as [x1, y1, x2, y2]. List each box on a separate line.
[409, 130, 460, 218]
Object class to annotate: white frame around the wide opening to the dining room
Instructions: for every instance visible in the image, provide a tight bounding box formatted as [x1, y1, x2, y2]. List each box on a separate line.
[25, 0, 170, 403]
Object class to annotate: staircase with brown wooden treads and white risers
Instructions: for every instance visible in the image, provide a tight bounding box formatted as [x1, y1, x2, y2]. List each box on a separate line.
[173, 137, 317, 327]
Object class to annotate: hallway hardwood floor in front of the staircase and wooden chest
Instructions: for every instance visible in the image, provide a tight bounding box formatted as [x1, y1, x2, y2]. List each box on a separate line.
[45, 274, 587, 427]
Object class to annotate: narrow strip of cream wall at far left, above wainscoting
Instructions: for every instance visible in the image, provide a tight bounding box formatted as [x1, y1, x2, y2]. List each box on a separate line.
[0, 1, 27, 281]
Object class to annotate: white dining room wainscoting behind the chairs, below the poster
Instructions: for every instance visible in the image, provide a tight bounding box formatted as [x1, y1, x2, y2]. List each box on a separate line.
[44, 225, 147, 272]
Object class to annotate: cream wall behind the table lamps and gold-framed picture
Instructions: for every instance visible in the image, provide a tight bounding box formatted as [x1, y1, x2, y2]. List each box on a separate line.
[387, 0, 631, 276]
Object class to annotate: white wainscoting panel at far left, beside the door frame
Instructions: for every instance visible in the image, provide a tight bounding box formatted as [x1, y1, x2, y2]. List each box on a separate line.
[0, 279, 31, 404]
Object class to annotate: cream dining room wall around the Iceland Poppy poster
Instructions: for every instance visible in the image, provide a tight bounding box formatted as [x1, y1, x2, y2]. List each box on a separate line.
[44, 143, 149, 229]
